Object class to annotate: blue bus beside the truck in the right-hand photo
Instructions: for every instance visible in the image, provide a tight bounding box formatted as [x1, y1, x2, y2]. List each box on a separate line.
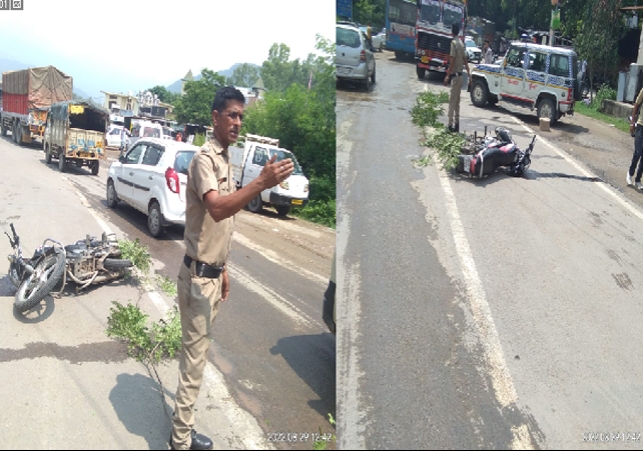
[386, 0, 418, 59]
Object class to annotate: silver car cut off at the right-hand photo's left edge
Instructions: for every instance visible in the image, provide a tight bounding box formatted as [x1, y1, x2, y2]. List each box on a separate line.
[335, 23, 376, 91]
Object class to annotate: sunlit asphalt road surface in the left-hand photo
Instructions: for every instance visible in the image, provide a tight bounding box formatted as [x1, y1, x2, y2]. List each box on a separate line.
[0, 136, 336, 449]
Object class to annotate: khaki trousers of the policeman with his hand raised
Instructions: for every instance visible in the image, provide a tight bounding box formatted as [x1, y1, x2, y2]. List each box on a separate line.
[172, 262, 221, 449]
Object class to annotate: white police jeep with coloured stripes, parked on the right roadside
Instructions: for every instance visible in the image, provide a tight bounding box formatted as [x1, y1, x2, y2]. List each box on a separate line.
[471, 42, 582, 125]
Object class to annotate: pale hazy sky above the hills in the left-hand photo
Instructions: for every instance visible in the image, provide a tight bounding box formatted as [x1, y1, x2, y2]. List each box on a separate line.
[0, 0, 336, 101]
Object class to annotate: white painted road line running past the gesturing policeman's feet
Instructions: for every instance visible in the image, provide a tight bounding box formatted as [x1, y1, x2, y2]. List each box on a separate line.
[64, 177, 275, 449]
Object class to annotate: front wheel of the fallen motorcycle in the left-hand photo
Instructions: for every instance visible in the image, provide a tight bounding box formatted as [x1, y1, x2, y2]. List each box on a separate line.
[13, 252, 65, 312]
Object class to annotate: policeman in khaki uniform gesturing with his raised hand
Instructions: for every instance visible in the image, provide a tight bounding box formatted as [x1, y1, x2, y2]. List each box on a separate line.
[170, 86, 294, 449]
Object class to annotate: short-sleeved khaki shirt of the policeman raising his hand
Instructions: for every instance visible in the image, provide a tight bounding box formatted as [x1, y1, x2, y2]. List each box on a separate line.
[184, 137, 236, 266]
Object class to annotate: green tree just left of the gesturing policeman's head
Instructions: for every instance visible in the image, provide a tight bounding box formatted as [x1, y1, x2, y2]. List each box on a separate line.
[174, 69, 225, 125]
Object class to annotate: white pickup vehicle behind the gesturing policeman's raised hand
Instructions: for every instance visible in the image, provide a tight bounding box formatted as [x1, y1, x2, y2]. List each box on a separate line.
[228, 135, 309, 216]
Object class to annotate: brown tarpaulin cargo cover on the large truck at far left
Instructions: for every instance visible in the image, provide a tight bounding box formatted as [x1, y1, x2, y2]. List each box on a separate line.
[2, 66, 73, 109]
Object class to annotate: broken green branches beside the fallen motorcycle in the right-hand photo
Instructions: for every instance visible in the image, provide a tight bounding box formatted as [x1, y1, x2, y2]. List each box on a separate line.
[411, 90, 466, 170]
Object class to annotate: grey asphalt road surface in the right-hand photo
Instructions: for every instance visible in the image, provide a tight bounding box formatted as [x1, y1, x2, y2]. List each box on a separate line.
[337, 52, 643, 449]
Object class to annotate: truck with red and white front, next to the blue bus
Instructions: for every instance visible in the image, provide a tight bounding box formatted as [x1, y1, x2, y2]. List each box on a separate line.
[415, 0, 467, 79]
